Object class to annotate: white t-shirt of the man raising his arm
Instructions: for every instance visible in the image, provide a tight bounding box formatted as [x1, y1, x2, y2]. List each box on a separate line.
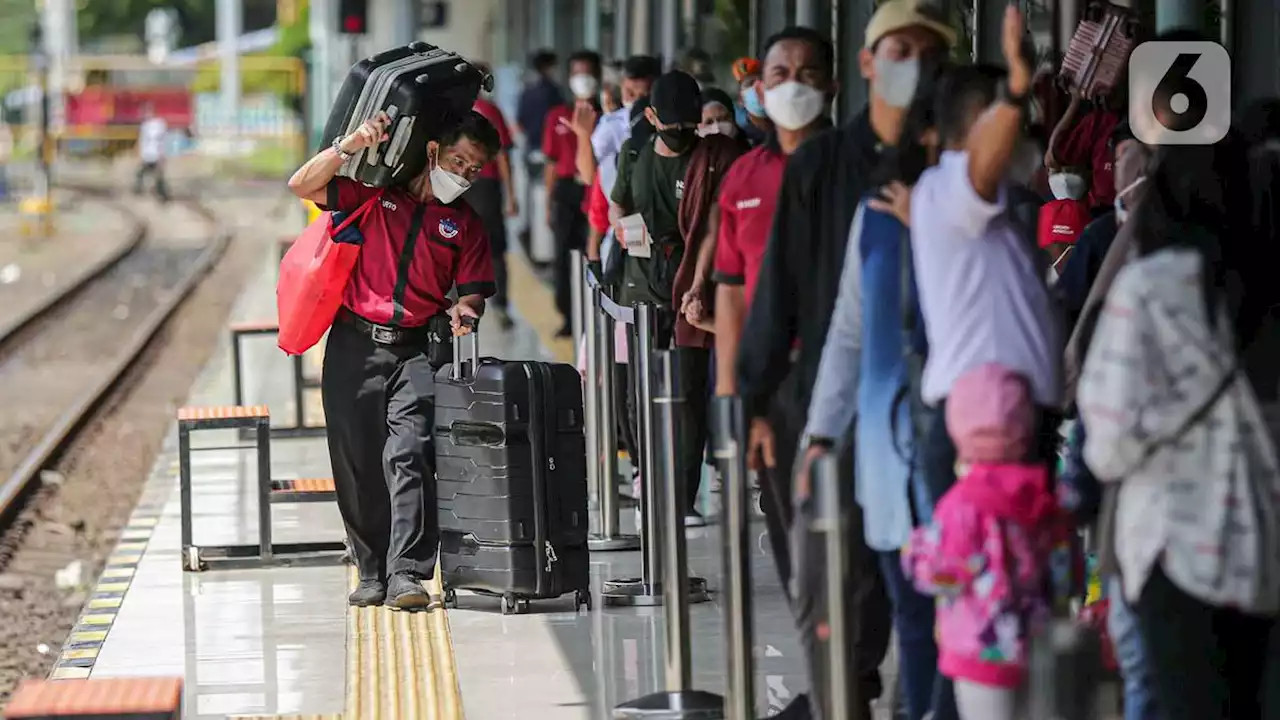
[911, 151, 1062, 407]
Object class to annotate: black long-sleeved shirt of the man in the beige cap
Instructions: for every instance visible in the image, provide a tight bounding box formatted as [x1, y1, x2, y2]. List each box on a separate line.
[737, 110, 881, 418]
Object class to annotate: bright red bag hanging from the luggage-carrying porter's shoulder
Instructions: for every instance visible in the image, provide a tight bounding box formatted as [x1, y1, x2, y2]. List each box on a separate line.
[275, 192, 381, 355]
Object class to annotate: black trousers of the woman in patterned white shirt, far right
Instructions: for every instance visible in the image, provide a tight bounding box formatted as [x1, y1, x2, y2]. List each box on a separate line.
[1134, 565, 1280, 720]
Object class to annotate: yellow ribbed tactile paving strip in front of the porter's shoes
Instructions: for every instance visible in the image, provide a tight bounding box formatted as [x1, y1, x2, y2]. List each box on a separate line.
[343, 569, 463, 720]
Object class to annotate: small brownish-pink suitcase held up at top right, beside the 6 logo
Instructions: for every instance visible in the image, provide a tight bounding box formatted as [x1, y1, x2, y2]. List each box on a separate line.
[1060, 1, 1138, 100]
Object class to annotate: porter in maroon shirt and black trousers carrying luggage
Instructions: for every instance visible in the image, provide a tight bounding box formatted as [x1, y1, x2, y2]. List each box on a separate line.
[289, 111, 500, 609]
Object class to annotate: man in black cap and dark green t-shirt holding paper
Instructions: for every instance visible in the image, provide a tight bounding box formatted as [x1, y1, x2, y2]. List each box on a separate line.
[613, 70, 741, 525]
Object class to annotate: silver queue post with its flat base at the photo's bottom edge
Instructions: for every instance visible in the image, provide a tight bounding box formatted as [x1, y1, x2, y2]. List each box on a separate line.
[613, 350, 724, 720]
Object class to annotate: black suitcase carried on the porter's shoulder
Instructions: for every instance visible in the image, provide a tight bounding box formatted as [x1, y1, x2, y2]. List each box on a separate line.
[323, 42, 493, 187]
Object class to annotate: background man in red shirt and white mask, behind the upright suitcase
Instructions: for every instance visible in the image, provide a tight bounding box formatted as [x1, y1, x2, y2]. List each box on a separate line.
[543, 50, 602, 337]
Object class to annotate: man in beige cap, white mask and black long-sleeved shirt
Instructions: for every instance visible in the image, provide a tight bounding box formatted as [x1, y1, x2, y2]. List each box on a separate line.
[737, 0, 955, 719]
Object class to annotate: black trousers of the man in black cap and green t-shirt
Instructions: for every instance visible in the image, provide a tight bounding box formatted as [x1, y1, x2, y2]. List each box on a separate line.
[622, 310, 710, 510]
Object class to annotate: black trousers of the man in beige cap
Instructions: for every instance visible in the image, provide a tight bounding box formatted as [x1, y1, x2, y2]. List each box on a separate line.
[760, 378, 893, 720]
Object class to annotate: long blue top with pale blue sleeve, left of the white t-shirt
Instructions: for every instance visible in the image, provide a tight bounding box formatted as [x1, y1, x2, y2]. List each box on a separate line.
[805, 204, 929, 551]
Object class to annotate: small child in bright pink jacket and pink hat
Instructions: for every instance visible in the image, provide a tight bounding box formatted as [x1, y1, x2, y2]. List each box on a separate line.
[902, 364, 1062, 720]
